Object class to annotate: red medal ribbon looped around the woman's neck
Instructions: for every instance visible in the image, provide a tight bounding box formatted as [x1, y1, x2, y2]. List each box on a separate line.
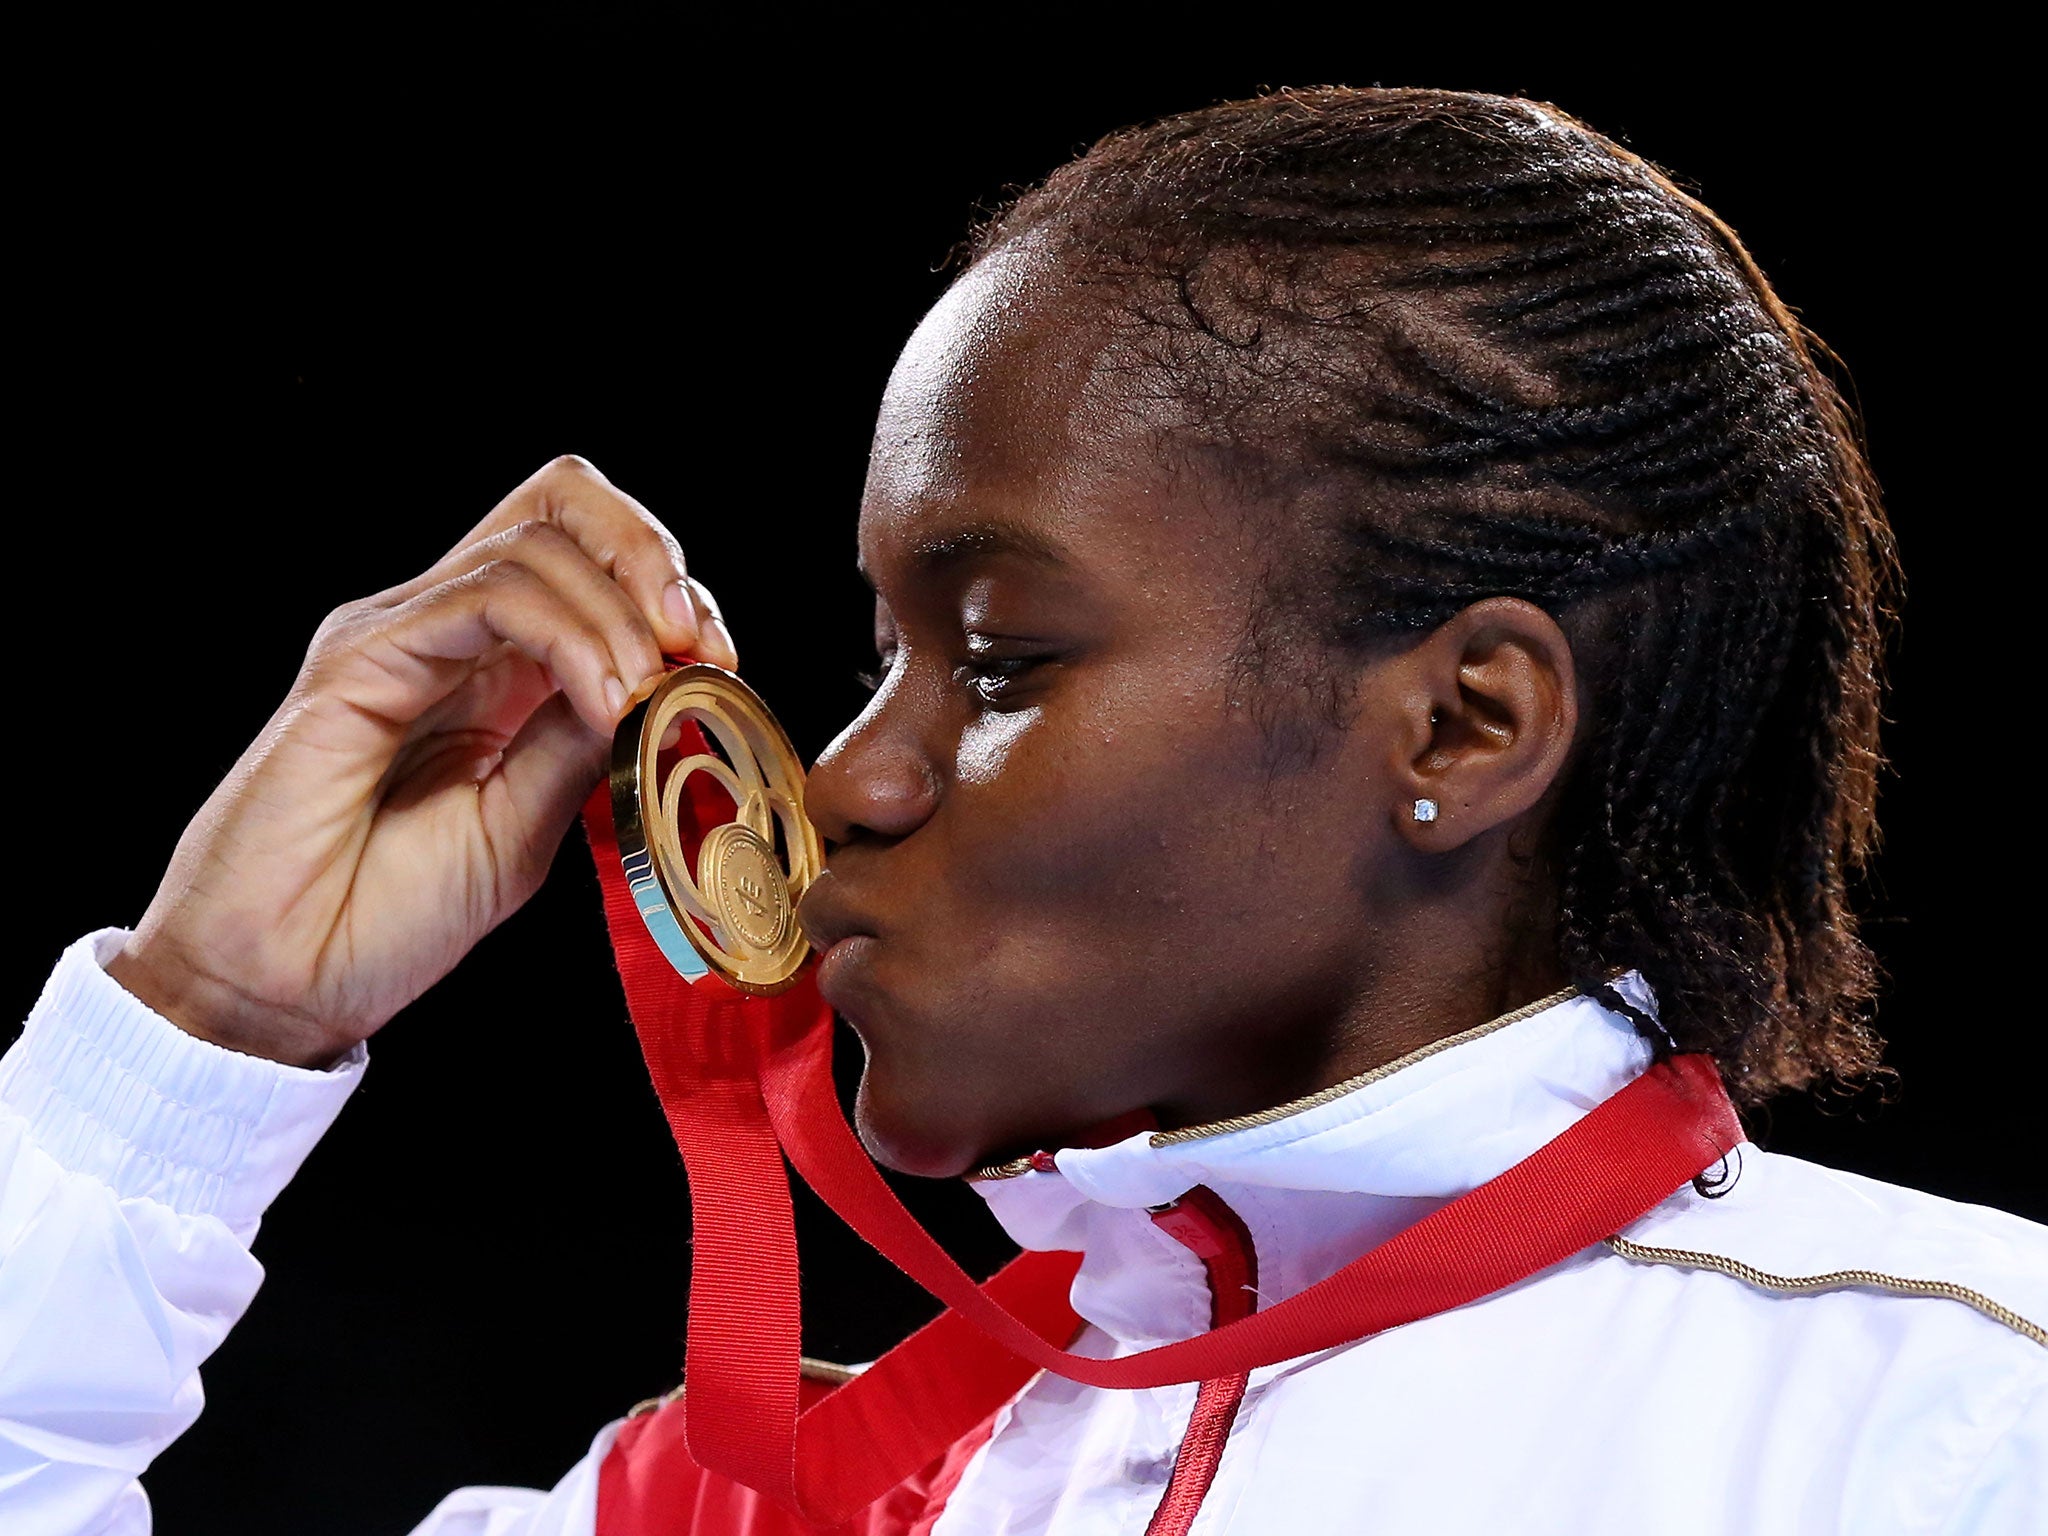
[584, 788, 1743, 1528]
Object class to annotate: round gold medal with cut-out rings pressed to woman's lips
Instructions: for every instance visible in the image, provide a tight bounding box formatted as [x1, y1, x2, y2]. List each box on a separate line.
[612, 664, 825, 995]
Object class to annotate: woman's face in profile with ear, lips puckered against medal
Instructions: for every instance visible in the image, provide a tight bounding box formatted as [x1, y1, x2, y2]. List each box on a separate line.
[803, 248, 1575, 1176]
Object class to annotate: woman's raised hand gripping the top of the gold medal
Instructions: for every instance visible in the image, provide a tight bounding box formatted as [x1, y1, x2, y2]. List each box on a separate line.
[109, 459, 737, 1065]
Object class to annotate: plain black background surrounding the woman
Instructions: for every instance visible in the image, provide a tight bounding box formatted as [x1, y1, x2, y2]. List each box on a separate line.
[6, 20, 2048, 1536]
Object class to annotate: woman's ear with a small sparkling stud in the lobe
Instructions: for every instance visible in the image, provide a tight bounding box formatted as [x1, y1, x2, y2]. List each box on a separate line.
[1389, 598, 1579, 854]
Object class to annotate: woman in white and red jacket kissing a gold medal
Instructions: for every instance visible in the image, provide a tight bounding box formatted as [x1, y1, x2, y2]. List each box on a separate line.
[0, 90, 2048, 1536]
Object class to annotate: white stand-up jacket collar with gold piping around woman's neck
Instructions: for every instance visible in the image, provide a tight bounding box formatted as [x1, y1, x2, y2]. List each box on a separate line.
[975, 973, 1651, 1348]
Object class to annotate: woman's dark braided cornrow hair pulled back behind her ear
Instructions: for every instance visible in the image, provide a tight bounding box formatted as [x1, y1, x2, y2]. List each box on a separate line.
[971, 88, 1896, 1102]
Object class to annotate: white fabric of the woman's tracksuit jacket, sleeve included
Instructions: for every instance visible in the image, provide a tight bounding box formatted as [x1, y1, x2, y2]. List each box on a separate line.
[0, 932, 2048, 1536]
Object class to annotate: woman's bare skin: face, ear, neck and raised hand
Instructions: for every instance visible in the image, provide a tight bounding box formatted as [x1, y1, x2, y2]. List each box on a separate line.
[115, 250, 1577, 1176]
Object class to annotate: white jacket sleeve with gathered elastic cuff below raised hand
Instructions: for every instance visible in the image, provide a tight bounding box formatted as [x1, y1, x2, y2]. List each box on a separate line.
[0, 930, 602, 1536]
